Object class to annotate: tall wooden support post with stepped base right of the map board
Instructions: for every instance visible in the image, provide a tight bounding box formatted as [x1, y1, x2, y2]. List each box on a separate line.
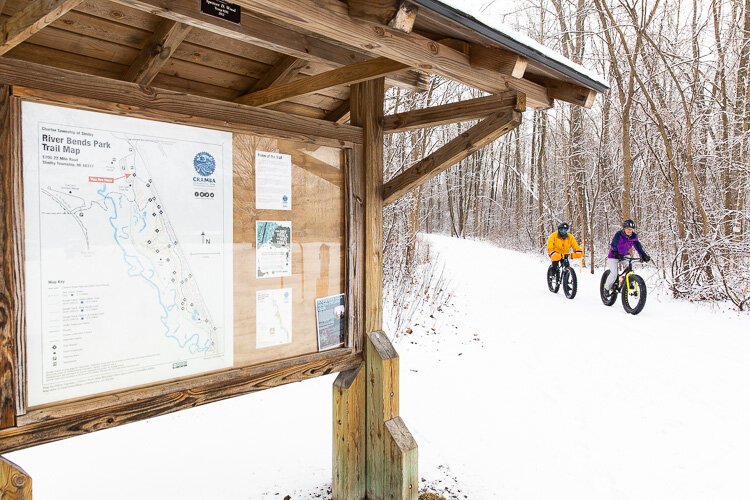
[333, 78, 418, 500]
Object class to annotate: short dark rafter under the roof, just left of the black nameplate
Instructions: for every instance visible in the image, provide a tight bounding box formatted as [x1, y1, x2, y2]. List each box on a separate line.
[124, 19, 193, 85]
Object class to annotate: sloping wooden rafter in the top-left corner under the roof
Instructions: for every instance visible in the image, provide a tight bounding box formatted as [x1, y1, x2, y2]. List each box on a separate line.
[0, 0, 83, 55]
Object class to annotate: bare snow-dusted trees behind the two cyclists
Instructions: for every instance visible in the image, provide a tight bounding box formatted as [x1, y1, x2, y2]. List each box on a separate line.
[385, 0, 750, 309]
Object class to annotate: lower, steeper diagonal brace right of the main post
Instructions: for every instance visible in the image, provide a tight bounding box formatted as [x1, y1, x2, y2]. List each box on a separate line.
[383, 111, 521, 203]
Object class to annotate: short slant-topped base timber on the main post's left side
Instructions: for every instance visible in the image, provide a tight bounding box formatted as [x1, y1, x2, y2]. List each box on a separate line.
[332, 365, 366, 500]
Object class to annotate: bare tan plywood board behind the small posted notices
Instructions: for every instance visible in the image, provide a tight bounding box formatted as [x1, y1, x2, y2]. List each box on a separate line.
[234, 134, 344, 366]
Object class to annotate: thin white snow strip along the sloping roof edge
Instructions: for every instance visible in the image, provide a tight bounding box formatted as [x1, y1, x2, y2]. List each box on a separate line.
[415, 0, 609, 92]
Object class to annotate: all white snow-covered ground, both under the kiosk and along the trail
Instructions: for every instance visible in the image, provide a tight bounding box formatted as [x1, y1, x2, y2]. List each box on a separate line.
[7, 236, 750, 500]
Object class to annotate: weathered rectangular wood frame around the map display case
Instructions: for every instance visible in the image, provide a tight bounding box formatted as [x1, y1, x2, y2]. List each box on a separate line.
[0, 59, 364, 453]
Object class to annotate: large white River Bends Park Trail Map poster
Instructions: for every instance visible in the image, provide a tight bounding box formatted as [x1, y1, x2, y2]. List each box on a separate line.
[22, 102, 233, 406]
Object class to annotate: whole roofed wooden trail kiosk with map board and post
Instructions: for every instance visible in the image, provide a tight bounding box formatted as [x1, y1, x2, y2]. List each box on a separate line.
[0, 0, 606, 499]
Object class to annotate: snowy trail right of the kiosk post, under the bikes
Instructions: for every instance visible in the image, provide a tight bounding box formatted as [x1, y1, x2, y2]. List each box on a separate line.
[399, 237, 750, 500]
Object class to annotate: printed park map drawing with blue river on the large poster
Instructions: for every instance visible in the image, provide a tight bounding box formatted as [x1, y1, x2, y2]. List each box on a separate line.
[42, 141, 217, 353]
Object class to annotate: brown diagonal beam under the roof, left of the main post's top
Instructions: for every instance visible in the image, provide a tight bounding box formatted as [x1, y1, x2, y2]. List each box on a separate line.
[235, 57, 406, 107]
